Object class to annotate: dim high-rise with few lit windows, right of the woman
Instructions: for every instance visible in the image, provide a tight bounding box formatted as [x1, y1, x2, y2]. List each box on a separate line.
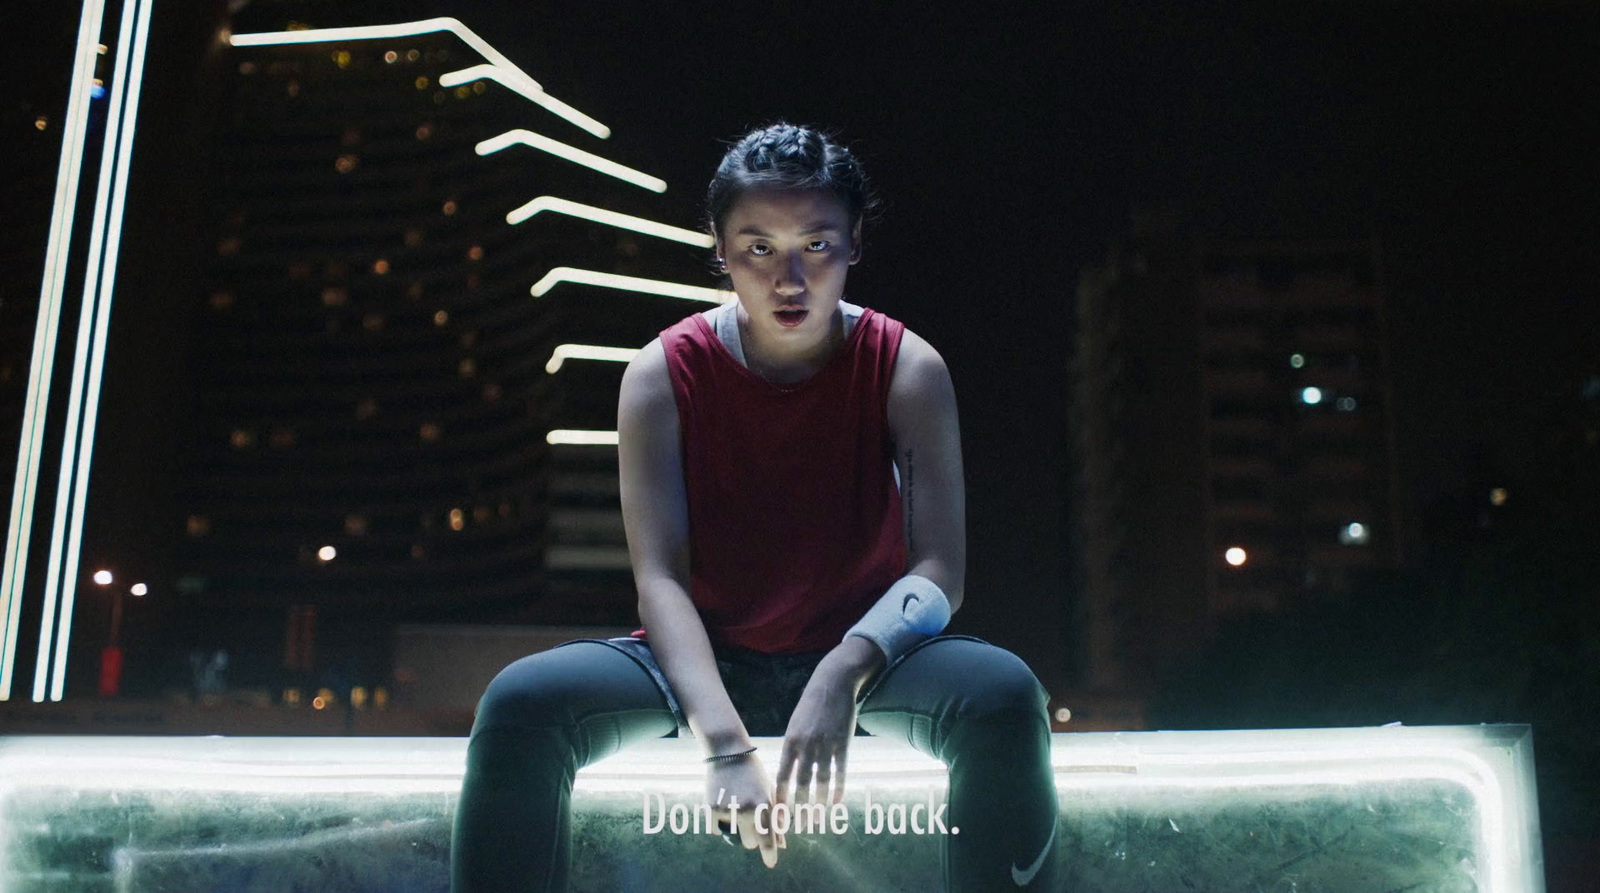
[1074, 211, 1403, 687]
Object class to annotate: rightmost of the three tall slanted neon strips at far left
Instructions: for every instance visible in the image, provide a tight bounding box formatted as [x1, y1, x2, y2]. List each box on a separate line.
[50, 0, 155, 701]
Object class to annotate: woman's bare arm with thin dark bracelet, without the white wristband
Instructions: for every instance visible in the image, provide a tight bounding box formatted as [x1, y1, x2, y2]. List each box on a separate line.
[616, 341, 784, 867]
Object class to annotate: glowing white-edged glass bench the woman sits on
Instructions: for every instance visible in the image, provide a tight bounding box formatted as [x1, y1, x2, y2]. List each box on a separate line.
[0, 725, 1544, 893]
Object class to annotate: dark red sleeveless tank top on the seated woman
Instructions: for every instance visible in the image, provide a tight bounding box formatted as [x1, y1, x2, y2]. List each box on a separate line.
[636, 309, 906, 655]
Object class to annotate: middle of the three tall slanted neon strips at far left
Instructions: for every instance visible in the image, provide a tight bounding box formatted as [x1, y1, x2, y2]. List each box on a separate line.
[34, 0, 138, 701]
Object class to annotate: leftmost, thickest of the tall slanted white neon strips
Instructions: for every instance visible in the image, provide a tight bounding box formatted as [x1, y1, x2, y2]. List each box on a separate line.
[0, 0, 106, 701]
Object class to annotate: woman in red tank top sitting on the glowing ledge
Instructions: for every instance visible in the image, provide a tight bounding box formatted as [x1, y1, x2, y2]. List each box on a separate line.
[451, 123, 1058, 893]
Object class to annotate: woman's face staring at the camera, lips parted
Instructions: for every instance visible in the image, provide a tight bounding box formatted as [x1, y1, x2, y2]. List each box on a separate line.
[717, 189, 861, 347]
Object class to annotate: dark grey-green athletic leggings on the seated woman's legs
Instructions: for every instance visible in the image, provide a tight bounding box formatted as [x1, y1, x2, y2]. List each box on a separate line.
[450, 639, 1058, 893]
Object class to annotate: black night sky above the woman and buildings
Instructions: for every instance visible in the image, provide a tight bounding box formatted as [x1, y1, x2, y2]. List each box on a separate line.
[3, 0, 1600, 678]
